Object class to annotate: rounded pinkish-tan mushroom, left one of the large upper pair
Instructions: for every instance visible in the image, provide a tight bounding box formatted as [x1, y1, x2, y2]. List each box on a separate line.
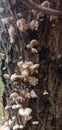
[17, 19, 26, 32]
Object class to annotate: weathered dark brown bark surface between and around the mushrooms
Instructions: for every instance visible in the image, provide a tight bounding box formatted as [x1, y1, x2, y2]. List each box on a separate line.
[0, 0, 62, 130]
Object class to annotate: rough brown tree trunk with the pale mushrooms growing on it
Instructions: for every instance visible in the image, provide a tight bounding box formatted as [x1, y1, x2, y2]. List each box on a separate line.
[0, 0, 62, 130]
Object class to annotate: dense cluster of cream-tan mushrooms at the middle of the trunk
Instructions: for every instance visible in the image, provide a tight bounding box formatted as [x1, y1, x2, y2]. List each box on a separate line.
[17, 61, 39, 86]
